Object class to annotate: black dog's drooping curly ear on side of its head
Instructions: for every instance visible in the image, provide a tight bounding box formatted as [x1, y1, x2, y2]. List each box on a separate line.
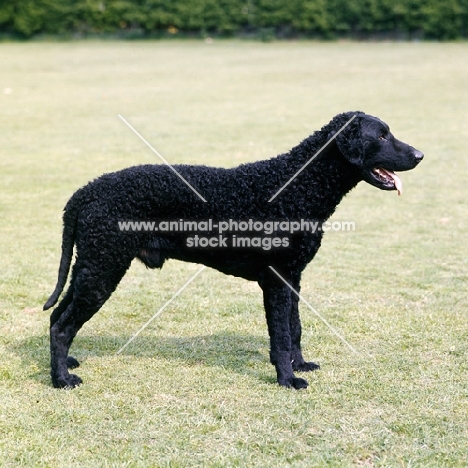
[328, 112, 364, 166]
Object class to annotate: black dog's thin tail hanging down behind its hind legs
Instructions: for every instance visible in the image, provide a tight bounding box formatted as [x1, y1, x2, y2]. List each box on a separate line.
[43, 197, 80, 310]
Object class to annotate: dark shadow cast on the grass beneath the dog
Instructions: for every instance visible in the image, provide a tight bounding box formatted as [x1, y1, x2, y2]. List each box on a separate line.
[12, 332, 275, 385]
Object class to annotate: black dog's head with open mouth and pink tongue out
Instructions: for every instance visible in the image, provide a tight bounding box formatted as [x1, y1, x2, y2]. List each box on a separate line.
[329, 112, 424, 194]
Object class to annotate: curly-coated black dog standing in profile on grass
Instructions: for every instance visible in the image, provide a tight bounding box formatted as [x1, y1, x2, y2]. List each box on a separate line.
[44, 112, 423, 388]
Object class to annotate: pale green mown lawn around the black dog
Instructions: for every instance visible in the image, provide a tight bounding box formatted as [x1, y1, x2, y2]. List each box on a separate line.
[0, 41, 468, 467]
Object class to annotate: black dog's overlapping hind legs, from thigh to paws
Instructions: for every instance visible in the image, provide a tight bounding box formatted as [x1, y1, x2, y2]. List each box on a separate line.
[50, 260, 130, 388]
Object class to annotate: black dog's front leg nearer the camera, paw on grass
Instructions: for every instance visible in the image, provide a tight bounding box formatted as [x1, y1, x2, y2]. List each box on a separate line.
[260, 280, 308, 389]
